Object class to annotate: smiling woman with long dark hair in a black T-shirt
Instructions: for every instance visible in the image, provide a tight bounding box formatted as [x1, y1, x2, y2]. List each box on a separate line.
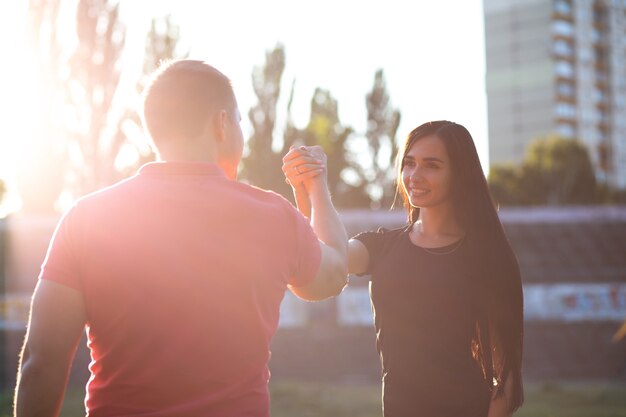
[283, 121, 523, 417]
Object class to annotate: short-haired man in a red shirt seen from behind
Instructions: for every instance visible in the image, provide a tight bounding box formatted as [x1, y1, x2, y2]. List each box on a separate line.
[15, 60, 346, 417]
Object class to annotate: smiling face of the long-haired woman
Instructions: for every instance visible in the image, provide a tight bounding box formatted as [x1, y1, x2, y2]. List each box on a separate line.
[402, 135, 452, 208]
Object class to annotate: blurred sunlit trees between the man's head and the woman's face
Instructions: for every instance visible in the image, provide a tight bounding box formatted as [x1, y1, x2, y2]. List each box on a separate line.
[241, 45, 400, 207]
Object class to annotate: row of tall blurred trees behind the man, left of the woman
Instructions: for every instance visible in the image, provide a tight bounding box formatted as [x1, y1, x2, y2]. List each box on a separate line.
[19, 0, 400, 210]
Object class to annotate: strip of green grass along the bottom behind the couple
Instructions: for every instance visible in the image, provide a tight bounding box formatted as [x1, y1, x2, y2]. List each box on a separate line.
[0, 381, 626, 417]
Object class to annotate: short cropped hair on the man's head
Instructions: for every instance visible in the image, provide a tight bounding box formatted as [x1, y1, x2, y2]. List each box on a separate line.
[142, 60, 236, 149]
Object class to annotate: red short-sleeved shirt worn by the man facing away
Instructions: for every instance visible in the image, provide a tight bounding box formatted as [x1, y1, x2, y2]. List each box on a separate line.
[40, 162, 320, 417]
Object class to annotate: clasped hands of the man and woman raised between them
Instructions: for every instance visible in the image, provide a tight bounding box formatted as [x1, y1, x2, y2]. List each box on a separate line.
[282, 146, 326, 193]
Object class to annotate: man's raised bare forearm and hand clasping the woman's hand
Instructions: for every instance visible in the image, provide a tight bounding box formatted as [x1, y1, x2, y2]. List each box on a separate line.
[284, 146, 348, 301]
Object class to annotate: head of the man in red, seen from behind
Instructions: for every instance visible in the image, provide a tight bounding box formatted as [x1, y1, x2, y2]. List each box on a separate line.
[143, 60, 243, 174]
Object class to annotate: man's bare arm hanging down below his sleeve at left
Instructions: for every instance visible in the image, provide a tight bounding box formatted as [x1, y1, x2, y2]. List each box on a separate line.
[14, 280, 86, 417]
